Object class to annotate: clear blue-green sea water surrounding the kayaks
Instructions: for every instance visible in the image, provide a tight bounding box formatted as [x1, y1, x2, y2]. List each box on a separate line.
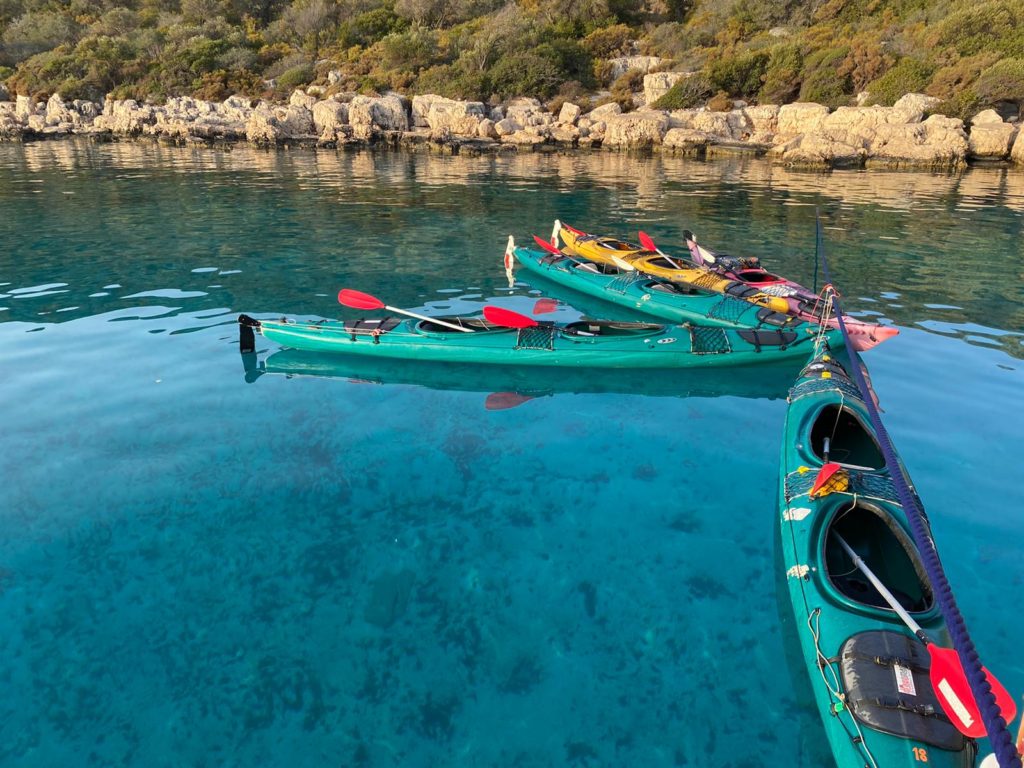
[0, 142, 1024, 767]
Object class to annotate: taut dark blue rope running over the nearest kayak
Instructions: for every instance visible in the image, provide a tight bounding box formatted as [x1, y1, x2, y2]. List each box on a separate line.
[817, 219, 1022, 768]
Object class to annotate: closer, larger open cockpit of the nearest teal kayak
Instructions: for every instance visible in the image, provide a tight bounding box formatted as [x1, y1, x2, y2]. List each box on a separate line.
[822, 503, 933, 613]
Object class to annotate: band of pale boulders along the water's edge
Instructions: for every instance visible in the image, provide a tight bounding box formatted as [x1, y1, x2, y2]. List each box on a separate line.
[0, 88, 1024, 169]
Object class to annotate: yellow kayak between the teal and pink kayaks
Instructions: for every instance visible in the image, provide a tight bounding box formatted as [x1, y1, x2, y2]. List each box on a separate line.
[552, 221, 791, 314]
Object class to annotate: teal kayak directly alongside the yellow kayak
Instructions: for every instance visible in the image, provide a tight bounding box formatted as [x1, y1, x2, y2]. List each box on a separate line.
[513, 247, 806, 328]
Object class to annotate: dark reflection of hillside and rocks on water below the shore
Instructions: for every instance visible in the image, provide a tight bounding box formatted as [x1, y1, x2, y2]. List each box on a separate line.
[0, 141, 1024, 357]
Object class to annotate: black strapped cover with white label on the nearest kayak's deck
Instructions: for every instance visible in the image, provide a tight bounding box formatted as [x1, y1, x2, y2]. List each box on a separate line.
[839, 630, 973, 753]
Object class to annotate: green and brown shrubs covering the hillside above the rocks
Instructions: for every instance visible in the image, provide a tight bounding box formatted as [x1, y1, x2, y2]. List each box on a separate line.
[0, 0, 1024, 117]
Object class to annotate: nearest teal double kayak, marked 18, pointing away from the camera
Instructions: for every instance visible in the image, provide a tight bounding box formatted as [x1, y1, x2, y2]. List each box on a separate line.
[776, 352, 977, 768]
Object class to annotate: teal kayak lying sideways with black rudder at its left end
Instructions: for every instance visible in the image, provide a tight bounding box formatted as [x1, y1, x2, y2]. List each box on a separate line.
[239, 314, 838, 369]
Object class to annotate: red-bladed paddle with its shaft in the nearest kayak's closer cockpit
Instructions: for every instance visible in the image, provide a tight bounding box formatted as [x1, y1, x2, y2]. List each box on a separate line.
[833, 530, 1017, 738]
